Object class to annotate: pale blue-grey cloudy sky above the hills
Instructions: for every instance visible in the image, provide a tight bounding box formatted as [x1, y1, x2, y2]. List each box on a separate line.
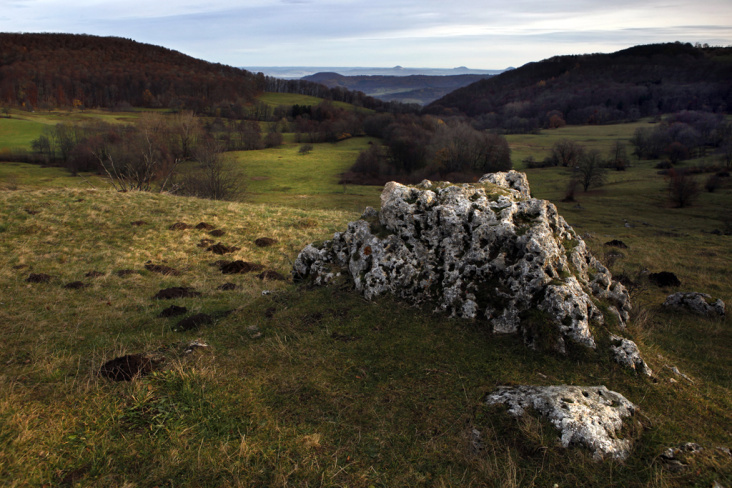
[0, 0, 732, 69]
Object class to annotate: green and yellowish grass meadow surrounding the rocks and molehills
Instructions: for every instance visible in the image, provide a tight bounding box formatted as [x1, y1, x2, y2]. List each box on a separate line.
[0, 108, 732, 488]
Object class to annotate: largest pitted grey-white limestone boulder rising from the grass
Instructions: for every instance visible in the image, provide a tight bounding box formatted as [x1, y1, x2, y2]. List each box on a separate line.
[293, 171, 630, 358]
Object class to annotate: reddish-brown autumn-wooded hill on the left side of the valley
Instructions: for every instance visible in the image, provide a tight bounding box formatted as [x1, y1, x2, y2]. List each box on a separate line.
[0, 34, 263, 112]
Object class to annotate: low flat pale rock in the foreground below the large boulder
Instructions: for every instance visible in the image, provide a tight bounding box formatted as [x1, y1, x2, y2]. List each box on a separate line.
[487, 385, 637, 460]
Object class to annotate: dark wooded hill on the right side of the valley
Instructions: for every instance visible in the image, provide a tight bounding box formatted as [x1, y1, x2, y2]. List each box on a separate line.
[426, 43, 732, 132]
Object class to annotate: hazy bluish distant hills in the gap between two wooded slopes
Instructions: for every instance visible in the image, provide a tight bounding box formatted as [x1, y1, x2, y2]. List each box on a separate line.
[302, 72, 491, 105]
